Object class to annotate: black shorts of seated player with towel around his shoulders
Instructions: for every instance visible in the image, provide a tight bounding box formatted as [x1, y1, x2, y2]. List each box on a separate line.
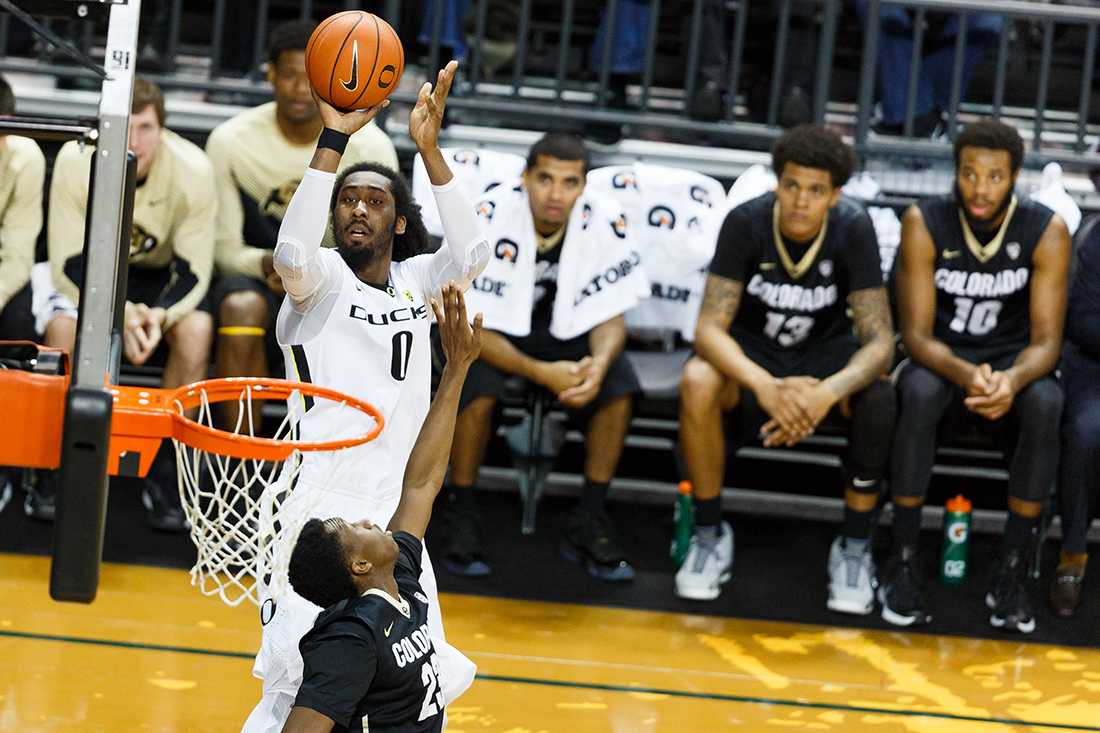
[459, 325, 641, 423]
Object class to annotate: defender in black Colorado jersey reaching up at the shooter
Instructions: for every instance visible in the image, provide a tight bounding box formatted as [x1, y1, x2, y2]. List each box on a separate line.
[283, 283, 482, 733]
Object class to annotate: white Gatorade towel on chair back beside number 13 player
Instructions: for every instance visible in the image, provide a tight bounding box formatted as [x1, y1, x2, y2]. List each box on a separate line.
[587, 163, 727, 341]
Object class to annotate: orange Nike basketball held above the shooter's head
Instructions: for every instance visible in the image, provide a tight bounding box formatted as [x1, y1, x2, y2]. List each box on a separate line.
[306, 10, 405, 111]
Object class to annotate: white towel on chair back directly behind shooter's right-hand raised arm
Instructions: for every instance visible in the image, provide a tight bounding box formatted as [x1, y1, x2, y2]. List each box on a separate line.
[413, 147, 527, 237]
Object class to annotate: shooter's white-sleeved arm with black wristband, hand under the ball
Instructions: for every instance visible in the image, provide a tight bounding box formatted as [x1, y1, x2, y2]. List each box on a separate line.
[272, 91, 389, 303]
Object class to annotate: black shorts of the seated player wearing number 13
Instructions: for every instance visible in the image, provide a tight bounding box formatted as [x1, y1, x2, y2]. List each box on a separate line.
[724, 335, 859, 449]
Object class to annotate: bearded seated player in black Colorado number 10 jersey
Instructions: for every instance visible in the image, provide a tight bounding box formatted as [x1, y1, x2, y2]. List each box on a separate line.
[879, 120, 1070, 633]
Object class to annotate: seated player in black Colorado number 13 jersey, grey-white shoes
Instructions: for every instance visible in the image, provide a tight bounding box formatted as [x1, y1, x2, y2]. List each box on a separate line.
[677, 125, 894, 614]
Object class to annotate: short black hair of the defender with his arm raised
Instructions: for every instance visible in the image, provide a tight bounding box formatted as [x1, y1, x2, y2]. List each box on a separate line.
[288, 519, 359, 609]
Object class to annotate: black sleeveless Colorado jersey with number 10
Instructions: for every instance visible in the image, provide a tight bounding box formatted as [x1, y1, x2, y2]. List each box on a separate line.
[920, 195, 1054, 363]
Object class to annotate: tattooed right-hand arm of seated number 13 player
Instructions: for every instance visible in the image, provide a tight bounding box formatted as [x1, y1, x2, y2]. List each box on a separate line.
[825, 287, 894, 400]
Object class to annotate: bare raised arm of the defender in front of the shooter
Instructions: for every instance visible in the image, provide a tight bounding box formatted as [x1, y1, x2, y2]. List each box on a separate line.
[388, 283, 482, 537]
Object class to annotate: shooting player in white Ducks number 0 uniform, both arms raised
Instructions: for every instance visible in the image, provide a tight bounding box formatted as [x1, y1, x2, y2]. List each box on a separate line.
[244, 62, 490, 733]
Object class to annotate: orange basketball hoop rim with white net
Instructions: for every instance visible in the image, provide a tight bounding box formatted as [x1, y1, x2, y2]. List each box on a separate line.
[109, 378, 384, 606]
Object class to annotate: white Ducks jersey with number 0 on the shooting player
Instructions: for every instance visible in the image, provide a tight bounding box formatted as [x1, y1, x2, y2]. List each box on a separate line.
[276, 250, 432, 510]
